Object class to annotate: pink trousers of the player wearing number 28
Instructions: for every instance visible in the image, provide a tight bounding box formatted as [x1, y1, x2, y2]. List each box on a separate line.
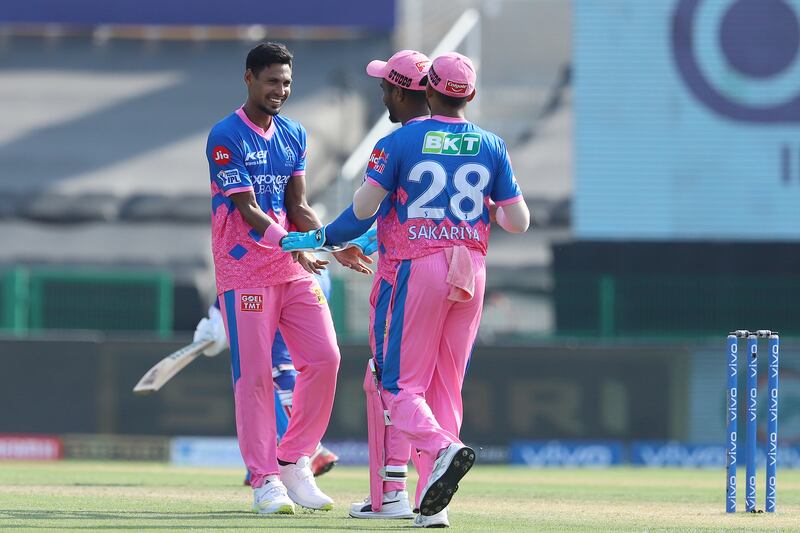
[382, 251, 486, 494]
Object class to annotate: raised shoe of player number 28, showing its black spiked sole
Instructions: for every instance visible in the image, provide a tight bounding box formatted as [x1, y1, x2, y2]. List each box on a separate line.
[419, 442, 475, 516]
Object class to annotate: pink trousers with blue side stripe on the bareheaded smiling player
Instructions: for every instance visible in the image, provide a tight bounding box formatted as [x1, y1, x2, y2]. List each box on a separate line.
[220, 277, 340, 488]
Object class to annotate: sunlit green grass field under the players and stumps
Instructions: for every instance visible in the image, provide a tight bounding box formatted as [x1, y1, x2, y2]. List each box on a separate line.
[0, 461, 800, 532]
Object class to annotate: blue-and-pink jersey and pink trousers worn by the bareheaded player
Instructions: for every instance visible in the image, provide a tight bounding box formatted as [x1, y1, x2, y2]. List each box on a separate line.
[206, 109, 339, 488]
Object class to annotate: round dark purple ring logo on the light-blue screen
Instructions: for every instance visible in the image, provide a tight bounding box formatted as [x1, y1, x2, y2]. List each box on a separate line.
[672, 0, 800, 123]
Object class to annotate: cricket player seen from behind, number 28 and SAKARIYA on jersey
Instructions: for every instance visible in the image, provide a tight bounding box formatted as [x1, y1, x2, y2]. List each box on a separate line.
[353, 53, 530, 527]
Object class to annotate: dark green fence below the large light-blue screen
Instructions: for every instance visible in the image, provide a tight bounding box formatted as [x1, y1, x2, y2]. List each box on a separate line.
[553, 274, 800, 337]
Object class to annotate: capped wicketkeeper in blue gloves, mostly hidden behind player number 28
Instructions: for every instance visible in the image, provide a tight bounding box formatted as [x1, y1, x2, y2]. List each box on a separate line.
[281, 50, 431, 519]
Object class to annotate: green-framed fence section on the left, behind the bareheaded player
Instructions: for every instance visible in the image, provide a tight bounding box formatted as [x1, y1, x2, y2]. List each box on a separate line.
[0, 268, 173, 336]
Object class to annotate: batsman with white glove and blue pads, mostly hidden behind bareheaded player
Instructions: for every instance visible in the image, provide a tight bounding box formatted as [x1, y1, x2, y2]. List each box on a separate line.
[194, 270, 339, 478]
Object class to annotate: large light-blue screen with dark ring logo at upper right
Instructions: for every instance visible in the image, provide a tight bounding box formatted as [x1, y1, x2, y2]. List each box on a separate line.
[574, 0, 800, 240]
